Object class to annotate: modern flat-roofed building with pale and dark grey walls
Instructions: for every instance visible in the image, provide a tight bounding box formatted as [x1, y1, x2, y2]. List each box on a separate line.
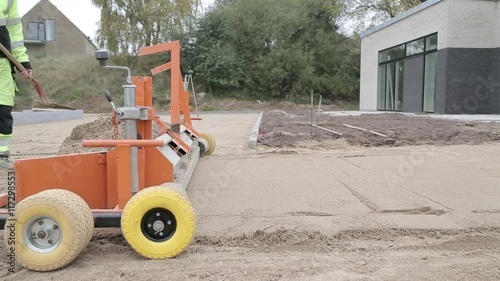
[360, 0, 500, 114]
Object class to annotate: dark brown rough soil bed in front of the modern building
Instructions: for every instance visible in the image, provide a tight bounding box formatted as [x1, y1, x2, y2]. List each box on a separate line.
[259, 112, 500, 147]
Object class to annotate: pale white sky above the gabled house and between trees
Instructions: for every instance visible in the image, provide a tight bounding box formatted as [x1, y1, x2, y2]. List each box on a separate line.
[18, 0, 213, 42]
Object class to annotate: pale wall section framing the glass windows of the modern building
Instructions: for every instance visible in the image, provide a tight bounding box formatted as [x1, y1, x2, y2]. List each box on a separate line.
[360, 0, 450, 111]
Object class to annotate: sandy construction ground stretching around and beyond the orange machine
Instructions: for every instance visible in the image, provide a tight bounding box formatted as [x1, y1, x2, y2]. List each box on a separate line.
[0, 112, 500, 281]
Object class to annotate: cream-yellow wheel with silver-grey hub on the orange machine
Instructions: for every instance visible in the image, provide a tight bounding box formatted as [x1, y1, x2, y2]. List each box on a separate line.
[4, 189, 94, 271]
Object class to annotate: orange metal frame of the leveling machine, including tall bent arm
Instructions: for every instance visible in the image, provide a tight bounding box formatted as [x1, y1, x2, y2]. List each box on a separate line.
[0, 41, 203, 223]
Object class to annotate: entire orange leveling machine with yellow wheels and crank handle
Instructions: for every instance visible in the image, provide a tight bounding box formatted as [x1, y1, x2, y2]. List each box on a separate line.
[0, 41, 215, 271]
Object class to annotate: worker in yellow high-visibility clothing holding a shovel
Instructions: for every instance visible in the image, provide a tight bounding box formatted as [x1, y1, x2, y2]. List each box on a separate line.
[0, 0, 32, 169]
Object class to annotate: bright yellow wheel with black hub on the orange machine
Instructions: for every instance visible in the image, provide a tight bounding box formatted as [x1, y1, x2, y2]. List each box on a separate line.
[121, 183, 196, 259]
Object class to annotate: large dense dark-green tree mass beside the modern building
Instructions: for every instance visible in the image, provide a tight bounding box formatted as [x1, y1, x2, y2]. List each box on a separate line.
[185, 0, 359, 101]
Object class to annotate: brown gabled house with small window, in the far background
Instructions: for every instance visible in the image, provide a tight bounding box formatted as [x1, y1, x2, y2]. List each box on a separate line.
[21, 0, 97, 56]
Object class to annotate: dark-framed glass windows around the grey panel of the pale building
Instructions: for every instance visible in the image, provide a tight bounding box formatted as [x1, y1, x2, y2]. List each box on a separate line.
[377, 34, 438, 112]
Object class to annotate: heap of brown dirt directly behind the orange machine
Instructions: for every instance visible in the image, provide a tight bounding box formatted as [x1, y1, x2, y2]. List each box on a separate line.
[59, 115, 161, 155]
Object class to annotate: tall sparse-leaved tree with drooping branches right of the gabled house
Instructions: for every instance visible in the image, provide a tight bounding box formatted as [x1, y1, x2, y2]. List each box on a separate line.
[92, 0, 200, 54]
